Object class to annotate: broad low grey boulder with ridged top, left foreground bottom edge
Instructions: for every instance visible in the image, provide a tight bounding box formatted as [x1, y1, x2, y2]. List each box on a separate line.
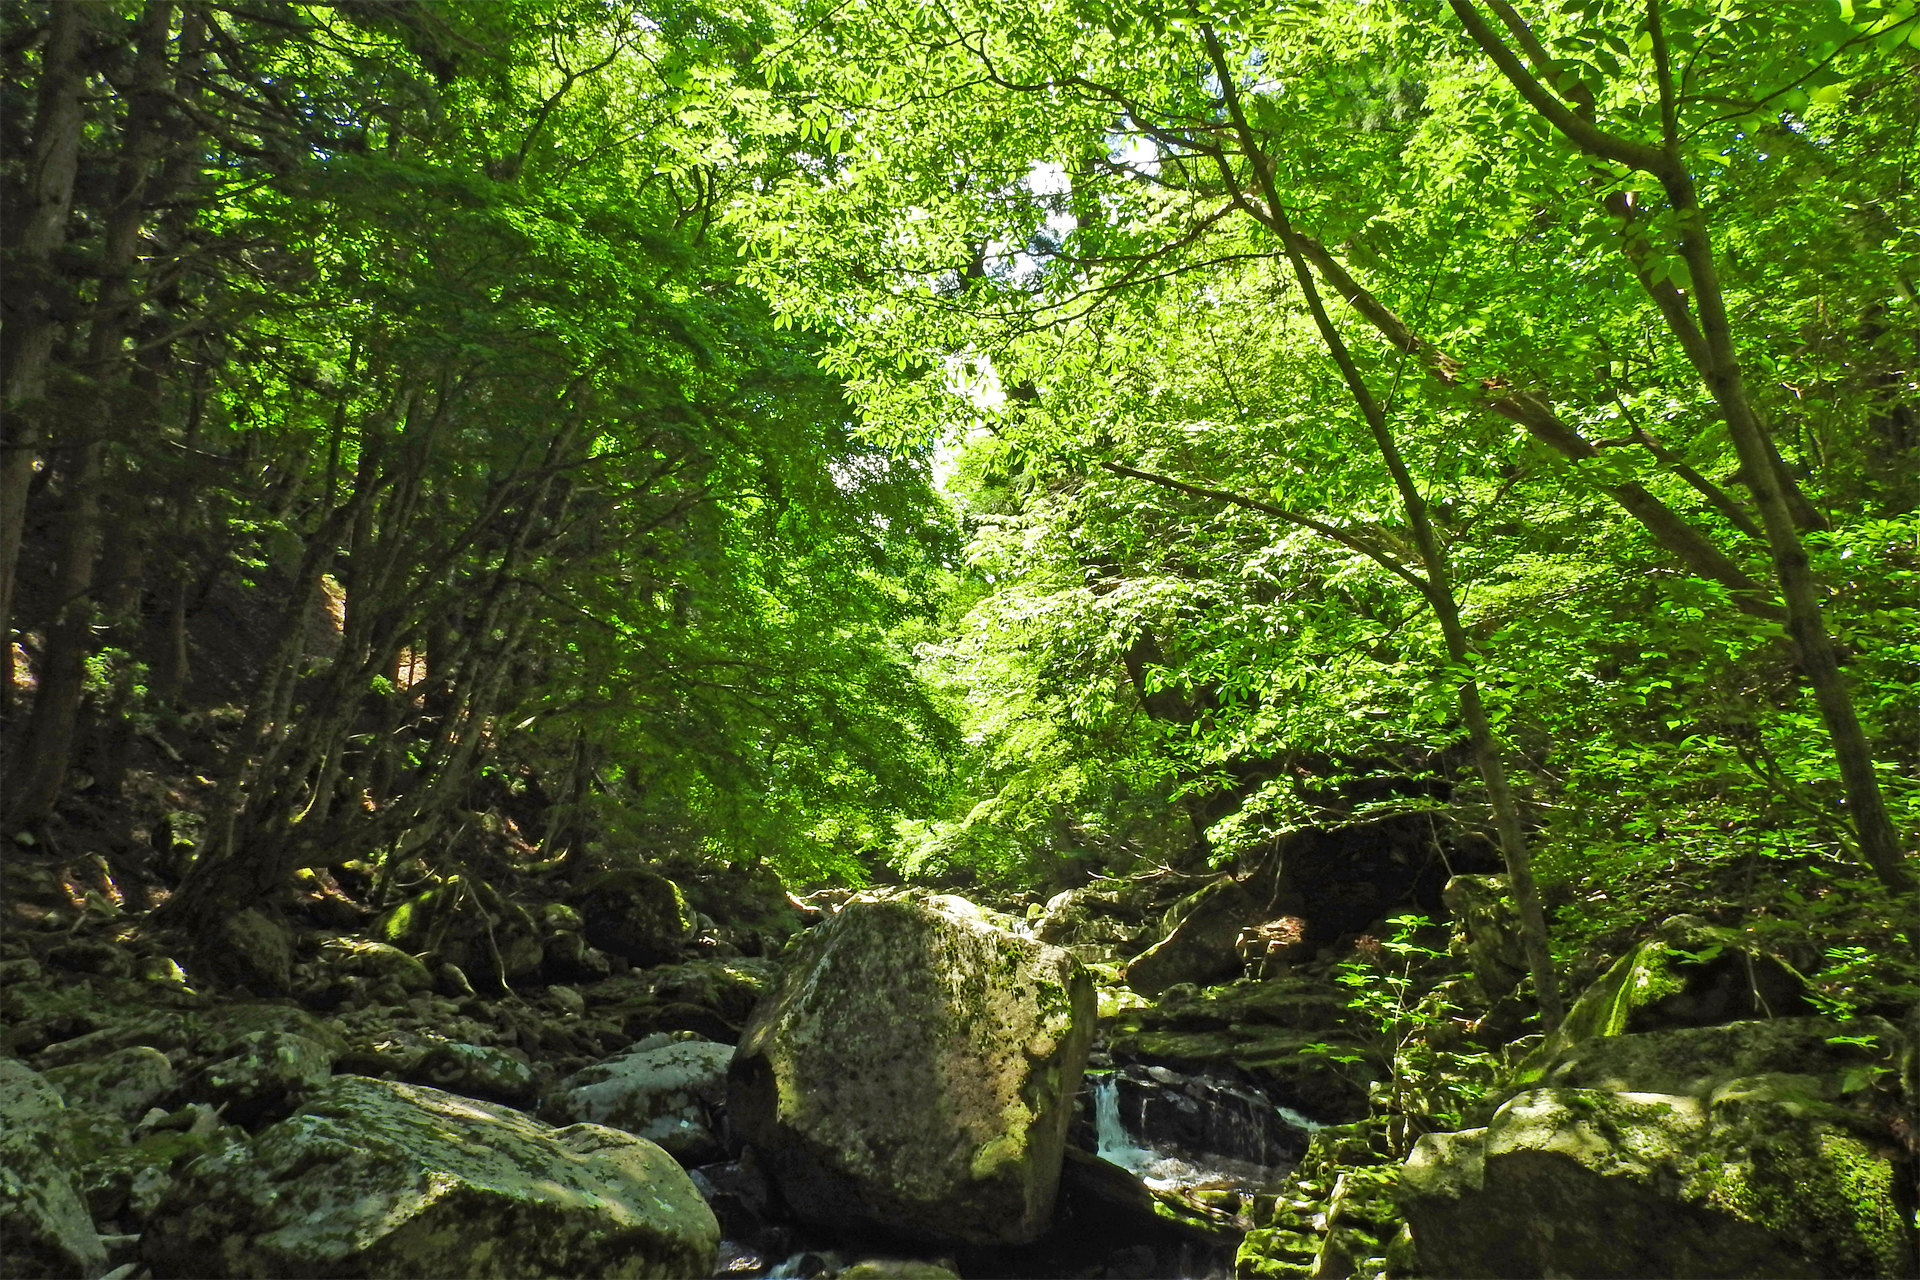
[142, 1077, 720, 1280]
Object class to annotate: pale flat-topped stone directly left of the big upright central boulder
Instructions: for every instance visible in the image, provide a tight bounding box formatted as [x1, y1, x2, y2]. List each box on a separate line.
[560, 1040, 733, 1165]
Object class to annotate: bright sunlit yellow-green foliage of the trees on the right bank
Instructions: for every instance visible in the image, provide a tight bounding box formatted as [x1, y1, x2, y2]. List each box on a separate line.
[710, 0, 1920, 921]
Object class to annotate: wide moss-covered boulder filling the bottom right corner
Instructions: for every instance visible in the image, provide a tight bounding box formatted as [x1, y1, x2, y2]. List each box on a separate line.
[1400, 1017, 1916, 1276]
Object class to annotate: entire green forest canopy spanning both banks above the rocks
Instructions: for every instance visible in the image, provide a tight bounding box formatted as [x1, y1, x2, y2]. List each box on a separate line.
[0, 0, 1920, 940]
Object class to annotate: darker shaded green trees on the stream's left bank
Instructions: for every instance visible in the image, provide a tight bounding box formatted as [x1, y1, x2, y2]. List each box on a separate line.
[0, 0, 952, 912]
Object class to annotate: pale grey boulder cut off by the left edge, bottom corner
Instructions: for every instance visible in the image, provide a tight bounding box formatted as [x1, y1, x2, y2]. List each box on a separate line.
[0, 1057, 108, 1276]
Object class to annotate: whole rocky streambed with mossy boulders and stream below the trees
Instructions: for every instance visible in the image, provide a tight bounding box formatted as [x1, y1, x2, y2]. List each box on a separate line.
[0, 855, 1920, 1280]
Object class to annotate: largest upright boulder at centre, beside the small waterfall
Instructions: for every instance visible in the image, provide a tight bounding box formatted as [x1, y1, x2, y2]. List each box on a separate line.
[728, 894, 1094, 1244]
